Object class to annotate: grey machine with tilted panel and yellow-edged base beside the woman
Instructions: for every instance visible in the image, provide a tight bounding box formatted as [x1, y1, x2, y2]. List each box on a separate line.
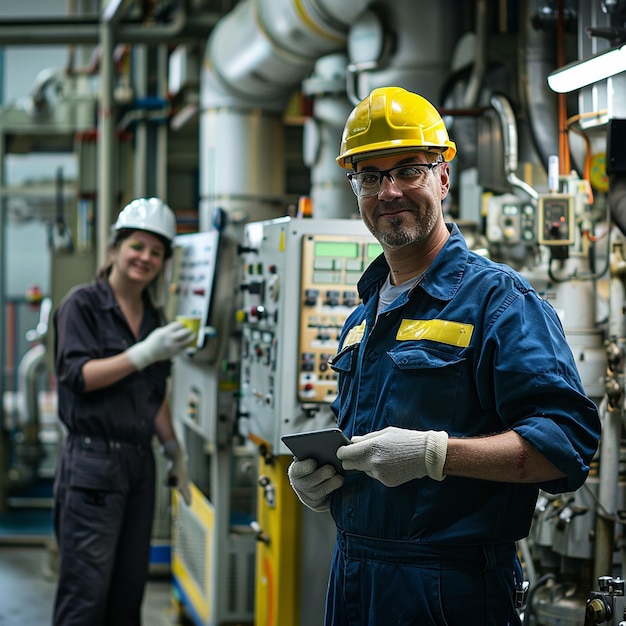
[166, 230, 255, 624]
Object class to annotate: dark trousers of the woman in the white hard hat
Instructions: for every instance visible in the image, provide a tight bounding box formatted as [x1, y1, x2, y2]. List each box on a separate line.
[53, 435, 155, 626]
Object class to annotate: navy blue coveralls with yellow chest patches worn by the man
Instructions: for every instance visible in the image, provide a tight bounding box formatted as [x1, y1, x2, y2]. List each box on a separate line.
[326, 225, 600, 626]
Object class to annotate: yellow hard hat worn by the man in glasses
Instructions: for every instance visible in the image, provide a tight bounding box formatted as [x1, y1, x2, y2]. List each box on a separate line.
[337, 87, 456, 169]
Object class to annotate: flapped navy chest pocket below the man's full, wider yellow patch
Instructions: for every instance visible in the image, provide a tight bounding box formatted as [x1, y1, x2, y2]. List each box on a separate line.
[384, 341, 467, 430]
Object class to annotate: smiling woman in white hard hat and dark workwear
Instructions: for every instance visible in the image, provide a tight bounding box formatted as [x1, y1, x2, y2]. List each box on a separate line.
[54, 198, 192, 626]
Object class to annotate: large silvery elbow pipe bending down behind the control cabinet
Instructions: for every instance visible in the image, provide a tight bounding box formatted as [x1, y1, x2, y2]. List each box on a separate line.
[200, 0, 368, 230]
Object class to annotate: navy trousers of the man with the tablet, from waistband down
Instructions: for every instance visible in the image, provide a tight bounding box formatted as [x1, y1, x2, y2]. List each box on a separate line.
[324, 532, 521, 626]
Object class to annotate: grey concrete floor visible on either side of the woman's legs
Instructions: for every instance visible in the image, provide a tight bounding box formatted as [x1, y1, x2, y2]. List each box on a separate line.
[0, 545, 179, 626]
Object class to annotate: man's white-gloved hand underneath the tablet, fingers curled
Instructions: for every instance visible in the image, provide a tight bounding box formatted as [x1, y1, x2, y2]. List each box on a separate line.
[287, 459, 343, 513]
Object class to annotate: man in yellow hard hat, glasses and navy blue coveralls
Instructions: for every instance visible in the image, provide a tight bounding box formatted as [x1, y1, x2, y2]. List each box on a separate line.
[289, 87, 600, 626]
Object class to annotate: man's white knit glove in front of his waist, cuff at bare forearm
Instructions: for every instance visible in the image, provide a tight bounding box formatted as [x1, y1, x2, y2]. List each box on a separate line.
[337, 426, 448, 487]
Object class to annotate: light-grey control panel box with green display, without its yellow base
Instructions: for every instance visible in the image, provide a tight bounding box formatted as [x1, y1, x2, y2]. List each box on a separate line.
[240, 217, 381, 454]
